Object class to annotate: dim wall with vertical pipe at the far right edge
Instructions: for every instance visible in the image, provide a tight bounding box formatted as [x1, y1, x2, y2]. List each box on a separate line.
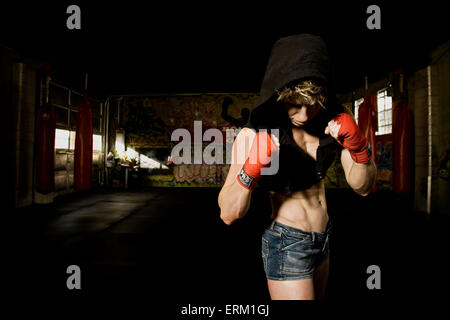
[408, 43, 450, 214]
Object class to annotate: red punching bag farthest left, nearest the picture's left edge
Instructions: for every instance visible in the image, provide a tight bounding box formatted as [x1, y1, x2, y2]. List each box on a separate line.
[36, 103, 56, 194]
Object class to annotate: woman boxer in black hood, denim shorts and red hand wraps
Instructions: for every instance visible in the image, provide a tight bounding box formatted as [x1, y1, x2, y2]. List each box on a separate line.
[218, 34, 376, 300]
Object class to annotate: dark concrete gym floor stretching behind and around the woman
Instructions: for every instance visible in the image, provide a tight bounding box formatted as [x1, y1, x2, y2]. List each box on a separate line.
[7, 188, 449, 312]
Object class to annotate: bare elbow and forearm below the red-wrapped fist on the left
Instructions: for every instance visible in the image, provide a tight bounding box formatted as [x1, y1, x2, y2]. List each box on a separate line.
[218, 181, 251, 225]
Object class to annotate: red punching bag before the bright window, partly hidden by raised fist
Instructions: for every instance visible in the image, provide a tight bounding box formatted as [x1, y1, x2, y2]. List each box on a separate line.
[358, 91, 378, 192]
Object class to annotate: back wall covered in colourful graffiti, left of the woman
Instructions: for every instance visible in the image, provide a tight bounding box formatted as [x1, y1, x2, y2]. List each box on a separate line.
[118, 93, 258, 187]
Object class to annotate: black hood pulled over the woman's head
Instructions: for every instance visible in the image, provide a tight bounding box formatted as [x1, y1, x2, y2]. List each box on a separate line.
[250, 34, 337, 132]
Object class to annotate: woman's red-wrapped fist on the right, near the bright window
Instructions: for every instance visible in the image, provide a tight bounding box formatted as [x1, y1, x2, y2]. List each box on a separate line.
[325, 113, 371, 163]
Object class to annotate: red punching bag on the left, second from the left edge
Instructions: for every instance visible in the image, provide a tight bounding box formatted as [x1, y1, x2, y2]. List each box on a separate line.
[73, 95, 93, 191]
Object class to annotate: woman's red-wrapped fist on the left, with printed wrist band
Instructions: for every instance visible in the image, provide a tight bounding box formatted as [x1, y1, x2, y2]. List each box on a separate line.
[237, 131, 280, 190]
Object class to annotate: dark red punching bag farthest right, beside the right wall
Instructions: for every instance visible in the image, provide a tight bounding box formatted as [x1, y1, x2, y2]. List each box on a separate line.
[392, 100, 413, 193]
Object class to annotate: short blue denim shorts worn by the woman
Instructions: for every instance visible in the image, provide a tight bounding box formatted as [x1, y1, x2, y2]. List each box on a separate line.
[261, 221, 331, 280]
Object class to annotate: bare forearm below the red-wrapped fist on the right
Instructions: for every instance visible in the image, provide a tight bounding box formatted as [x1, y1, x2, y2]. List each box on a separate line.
[342, 149, 377, 196]
